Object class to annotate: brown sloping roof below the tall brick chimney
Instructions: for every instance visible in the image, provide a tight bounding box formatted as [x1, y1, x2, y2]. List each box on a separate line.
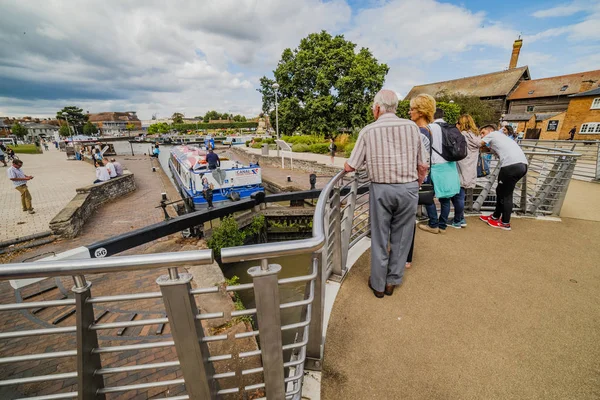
[404, 66, 529, 100]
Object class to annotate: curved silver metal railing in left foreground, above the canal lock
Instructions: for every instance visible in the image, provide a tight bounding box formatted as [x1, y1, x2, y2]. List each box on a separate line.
[0, 173, 370, 400]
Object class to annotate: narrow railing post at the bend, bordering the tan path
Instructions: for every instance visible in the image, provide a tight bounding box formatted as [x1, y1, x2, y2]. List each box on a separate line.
[304, 253, 326, 371]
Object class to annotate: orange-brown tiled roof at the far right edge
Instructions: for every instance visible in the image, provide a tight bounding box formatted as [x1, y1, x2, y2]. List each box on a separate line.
[508, 70, 600, 100]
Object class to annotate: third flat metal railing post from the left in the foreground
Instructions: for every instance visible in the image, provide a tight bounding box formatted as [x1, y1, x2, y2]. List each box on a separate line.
[248, 259, 285, 399]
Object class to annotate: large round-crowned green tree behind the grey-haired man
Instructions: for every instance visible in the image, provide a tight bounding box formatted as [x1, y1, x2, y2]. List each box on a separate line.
[258, 31, 389, 133]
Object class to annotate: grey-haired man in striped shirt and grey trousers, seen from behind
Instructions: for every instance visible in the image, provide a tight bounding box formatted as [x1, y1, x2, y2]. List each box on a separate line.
[345, 90, 428, 298]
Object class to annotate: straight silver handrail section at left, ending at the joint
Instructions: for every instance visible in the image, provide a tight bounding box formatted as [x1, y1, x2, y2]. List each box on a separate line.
[0, 250, 213, 280]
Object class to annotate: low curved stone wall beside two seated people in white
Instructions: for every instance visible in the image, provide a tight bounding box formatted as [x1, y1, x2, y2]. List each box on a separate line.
[50, 170, 136, 239]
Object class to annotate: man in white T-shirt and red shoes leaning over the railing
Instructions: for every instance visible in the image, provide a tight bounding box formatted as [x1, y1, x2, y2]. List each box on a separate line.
[479, 125, 528, 231]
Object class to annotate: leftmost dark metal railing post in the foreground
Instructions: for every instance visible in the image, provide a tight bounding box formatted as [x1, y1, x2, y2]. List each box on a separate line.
[72, 275, 106, 400]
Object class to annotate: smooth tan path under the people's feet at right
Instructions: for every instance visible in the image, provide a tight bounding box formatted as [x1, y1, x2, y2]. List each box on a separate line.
[322, 183, 600, 399]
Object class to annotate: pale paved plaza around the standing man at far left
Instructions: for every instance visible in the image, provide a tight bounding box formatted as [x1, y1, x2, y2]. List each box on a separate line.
[0, 149, 96, 241]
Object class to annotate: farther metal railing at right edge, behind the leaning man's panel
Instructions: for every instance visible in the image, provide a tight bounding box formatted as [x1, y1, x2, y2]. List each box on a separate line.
[521, 139, 600, 181]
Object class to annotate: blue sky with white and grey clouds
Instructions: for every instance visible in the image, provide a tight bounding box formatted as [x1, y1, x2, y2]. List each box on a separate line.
[0, 0, 600, 119]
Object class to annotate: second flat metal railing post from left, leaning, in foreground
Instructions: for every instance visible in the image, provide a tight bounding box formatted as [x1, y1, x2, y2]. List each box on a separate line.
[156, 268, 218, 400]
